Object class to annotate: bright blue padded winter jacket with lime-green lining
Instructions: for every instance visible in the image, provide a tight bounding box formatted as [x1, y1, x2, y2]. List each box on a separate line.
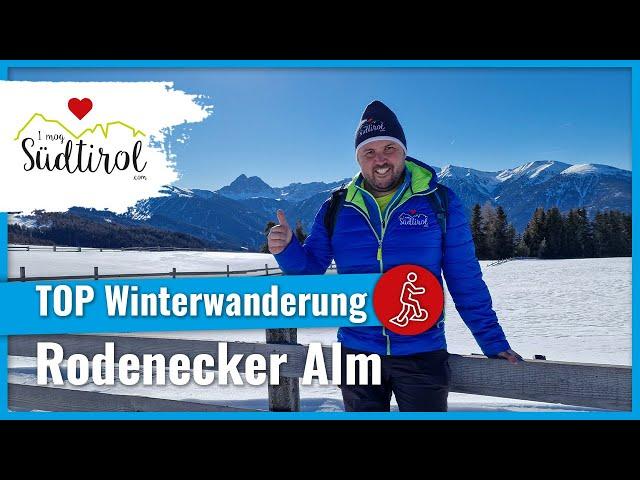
[275, 157, 510, 356]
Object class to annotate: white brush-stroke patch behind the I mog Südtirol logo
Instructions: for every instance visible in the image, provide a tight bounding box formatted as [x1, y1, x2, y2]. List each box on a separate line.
[0, 81, 212, 213]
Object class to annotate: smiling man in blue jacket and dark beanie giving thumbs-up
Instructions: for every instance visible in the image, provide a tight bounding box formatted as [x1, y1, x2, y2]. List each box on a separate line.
[268, 101, 522, 411]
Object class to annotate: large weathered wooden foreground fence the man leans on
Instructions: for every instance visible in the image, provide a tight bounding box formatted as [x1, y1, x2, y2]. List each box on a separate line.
[9, 329, 631, 411]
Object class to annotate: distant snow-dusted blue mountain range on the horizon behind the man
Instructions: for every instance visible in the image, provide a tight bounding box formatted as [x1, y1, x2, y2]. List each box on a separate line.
[12, 161, 631, 251]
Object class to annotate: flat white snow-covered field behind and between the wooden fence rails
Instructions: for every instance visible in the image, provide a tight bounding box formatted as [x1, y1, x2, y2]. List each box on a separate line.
[9, 251, 631, 411]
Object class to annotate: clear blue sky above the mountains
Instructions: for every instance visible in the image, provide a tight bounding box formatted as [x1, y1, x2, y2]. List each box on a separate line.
[9, 68, 631, 190]
